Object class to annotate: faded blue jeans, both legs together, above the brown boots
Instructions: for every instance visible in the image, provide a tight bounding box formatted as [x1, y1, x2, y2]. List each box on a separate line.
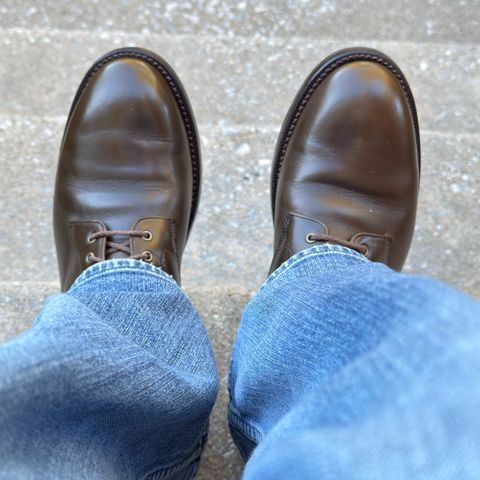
[0, 249, 480, 480]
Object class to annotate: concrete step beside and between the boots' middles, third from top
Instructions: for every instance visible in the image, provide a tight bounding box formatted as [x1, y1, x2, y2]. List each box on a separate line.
[0, 116, 480, 297]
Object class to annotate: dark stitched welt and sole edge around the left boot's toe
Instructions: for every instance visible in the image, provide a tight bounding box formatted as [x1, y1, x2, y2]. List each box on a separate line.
[62, 47, 202, 237]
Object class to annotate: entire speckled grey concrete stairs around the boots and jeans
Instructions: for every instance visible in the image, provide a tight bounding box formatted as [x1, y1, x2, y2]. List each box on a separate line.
[0, 0, 480, 480]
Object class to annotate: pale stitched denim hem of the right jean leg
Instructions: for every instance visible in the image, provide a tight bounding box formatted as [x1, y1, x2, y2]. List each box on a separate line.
[260, 243, 370, 291]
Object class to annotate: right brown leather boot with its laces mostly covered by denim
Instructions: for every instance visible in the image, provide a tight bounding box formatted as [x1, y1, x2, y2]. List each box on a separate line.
[270, 48, 420, 272]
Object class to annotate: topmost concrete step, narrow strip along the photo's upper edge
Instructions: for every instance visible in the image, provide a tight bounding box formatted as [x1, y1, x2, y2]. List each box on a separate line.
[0, 0, 480, 43]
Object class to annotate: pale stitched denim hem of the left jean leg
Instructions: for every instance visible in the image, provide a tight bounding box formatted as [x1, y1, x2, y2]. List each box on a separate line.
[68, 258, 178, 293]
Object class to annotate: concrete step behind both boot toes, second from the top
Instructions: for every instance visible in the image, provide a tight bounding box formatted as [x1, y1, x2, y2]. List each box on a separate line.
[0, 28, 480, 133]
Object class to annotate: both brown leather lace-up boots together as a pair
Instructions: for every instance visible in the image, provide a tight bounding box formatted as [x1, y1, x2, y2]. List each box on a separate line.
[54, 48, 420, 291]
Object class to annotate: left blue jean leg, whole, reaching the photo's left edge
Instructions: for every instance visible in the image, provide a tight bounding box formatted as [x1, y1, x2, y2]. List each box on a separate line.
[0, 260, 218, 480]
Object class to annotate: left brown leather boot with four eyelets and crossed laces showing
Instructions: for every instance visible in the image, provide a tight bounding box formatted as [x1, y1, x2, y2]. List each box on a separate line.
[54, 48, 200, 291]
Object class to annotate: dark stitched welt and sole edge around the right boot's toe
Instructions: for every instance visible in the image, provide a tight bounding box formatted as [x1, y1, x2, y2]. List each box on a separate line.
[270, 47, 421, 220]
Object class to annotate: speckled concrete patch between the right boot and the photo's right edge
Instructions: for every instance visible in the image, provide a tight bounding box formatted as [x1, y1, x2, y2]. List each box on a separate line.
[405, 135, 480, 298]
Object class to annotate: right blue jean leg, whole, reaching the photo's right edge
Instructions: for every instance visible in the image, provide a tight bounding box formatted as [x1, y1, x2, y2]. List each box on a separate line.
[229, 245, 480, 480]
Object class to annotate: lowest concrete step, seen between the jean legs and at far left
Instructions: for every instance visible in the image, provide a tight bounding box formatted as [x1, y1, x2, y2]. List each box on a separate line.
[0, 281, 250, 480]
